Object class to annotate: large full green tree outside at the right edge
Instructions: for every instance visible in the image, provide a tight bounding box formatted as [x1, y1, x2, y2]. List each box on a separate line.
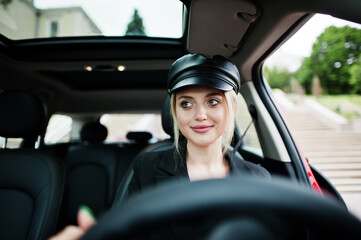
[296, 26, 361, 94]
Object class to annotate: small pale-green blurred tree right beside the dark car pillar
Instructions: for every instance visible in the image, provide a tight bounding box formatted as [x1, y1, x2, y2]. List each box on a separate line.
[263, 67, 293, 92]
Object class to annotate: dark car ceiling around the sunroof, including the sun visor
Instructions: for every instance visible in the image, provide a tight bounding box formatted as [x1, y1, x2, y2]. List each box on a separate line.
[0, 0, 361, 114]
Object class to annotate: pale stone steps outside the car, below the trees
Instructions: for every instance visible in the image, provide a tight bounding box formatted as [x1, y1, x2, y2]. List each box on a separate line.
[275, 94, 361, 219]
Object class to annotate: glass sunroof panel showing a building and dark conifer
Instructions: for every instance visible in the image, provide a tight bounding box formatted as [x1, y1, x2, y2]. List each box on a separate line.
[0, 0, 183, 40]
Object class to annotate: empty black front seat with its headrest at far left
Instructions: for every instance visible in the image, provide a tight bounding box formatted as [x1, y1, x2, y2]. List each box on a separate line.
[0, 90, 65, 239]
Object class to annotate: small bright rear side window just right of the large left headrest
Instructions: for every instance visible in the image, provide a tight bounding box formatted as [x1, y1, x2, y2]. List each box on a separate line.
[44, 114, 73, 144]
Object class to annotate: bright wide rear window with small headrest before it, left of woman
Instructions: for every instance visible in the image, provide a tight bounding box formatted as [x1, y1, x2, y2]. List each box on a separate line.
[100, 114, 169, 142]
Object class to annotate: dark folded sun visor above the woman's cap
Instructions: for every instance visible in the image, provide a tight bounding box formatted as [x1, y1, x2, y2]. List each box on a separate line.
[187, 0, 259, 57]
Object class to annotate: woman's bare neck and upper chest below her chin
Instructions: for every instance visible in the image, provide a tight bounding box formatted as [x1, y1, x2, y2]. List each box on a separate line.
[186, 139, 229, 181]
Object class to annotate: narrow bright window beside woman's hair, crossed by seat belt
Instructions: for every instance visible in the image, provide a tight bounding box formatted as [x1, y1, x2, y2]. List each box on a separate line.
[236, 95, 263, 156]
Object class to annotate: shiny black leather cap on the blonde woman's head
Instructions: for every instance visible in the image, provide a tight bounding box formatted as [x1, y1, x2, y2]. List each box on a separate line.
[167, 53, 241, 94]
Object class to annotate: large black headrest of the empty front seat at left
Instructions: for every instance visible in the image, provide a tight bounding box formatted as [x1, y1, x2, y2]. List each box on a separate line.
[0, 90, 46, 138]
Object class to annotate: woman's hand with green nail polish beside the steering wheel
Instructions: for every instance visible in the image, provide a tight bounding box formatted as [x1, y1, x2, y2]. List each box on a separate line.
[50, 206, 96, 240]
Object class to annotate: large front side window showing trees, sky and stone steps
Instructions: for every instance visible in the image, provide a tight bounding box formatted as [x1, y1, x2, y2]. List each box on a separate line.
[263, 14, 361, 218]
